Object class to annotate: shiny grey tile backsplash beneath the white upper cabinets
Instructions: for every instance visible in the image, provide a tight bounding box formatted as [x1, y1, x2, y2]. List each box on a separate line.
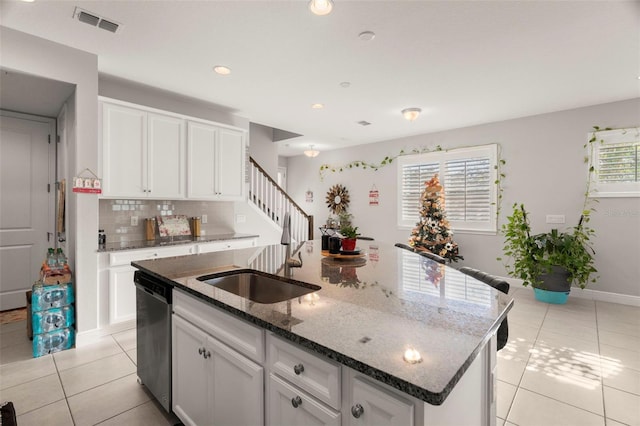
[101, 199, 234, 243]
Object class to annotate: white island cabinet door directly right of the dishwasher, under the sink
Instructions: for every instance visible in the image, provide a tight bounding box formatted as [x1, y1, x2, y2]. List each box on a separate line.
[171, 315, 213, 426]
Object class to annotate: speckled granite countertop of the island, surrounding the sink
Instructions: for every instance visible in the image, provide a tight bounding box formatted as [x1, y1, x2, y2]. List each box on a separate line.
[133, 240, 513, 405]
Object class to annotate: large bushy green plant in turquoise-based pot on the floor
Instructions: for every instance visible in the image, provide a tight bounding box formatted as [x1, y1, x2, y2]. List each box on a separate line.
[498, 203, 597, 303]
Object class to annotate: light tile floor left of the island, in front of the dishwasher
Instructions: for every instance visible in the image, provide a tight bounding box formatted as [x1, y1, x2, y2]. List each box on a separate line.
[0, 321, 179, 426]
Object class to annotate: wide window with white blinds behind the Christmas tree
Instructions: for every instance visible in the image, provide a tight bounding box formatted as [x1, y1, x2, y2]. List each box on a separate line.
[398, 144, 498, 233]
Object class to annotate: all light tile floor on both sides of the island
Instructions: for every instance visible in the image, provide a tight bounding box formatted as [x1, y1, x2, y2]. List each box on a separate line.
[0, 289, 640, 426]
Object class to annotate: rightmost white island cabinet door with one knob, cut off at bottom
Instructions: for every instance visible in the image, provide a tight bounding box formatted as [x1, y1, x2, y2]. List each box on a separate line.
[344, 377, 414, 426]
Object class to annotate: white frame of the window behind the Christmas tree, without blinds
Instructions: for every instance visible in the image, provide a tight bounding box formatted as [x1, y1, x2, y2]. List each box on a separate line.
[396, 144, 498, 235]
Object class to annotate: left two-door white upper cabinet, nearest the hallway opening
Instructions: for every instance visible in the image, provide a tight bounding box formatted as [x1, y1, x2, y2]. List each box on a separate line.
[101, 102, 185, 199]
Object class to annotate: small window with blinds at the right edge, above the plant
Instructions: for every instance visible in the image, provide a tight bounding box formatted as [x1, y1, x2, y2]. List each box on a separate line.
[589, 129, 640, 197]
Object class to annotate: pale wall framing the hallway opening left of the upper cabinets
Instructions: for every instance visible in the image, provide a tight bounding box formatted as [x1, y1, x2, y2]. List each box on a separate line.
[0, 27, 98, 332]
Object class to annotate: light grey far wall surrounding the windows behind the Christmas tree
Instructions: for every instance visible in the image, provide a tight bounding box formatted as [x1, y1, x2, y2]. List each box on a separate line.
[288, 98, 640, 296]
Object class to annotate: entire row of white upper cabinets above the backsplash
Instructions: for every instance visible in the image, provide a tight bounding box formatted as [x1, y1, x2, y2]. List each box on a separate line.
[100, 98, 246, 201]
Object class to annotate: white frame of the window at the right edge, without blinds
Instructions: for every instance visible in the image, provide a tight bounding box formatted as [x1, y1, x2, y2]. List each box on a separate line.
[588, 127, 640, 198]
